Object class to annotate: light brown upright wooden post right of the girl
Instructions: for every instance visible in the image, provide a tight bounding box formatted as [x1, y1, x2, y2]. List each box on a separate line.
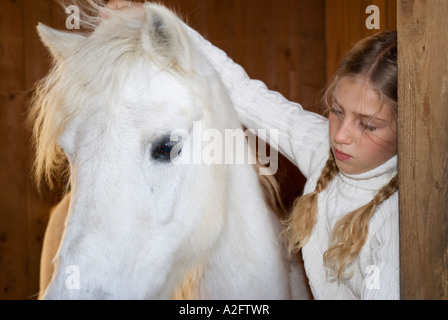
[398, 0, 448, 299]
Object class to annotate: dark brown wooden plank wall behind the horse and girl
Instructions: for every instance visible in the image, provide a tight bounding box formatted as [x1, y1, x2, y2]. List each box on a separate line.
[0, 0, 396, 299]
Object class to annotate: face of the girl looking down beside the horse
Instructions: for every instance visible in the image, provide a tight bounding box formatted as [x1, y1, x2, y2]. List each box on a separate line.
[329, 80, 397, 174]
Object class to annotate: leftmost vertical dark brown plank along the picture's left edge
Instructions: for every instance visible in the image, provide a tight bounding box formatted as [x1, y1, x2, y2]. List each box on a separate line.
[0, 1, 28, 299]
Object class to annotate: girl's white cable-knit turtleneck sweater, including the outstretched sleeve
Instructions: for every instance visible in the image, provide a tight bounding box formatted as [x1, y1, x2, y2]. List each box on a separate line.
[187, 28, 400, 299]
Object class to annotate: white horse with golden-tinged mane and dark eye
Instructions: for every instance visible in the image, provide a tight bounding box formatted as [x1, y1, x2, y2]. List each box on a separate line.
[33, 4, 308, 299]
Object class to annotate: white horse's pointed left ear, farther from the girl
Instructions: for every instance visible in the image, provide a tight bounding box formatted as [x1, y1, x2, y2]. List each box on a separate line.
[37, 23, 86, 60]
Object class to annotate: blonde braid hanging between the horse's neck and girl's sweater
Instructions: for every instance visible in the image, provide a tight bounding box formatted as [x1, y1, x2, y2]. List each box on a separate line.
[283, 150, 339, 254]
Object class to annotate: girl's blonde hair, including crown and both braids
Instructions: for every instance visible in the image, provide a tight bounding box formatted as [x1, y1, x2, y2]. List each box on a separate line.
[284, 31, 398, 279]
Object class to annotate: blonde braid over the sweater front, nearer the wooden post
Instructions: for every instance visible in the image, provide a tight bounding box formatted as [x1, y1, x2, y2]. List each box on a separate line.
[324, 175, 398, 278]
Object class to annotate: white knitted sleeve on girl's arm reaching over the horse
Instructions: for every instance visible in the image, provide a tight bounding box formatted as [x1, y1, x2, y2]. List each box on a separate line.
[186, 26, 330, 178]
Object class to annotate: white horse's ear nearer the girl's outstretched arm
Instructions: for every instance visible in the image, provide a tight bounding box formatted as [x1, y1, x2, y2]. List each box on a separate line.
[141, 4, 191, 71]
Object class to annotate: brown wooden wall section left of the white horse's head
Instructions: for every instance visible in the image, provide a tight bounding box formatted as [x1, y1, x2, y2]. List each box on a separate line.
[0, 0, 66, 299]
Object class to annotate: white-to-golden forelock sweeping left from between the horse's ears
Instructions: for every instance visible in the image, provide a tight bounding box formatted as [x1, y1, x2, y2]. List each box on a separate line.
[30, 7, 197, 187]
